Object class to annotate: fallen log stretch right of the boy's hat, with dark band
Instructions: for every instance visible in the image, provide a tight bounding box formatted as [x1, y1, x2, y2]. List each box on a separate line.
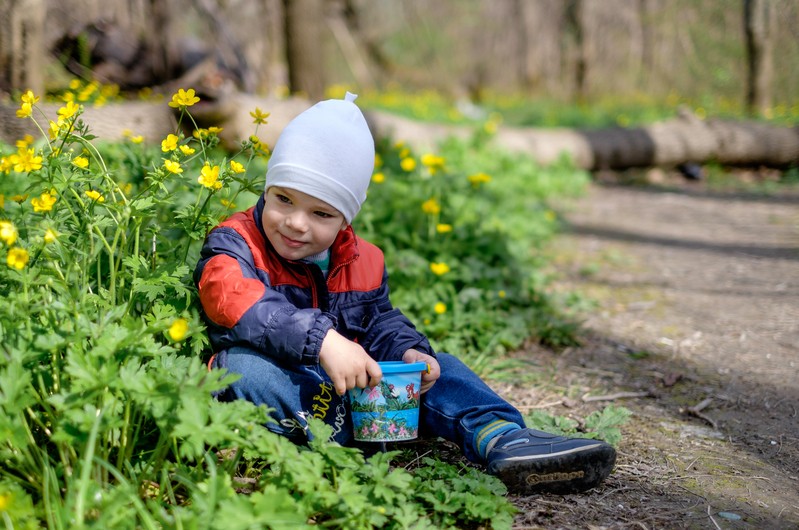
[367, 108, 799, 170]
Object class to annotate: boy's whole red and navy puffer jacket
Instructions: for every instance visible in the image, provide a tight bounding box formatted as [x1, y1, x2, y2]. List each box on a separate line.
[194, 196, 434, 364]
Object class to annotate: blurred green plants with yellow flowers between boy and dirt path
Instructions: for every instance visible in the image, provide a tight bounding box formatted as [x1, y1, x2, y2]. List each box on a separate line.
[356, 131, 587, 372]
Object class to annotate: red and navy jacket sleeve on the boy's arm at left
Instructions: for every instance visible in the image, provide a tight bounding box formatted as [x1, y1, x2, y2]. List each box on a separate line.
[194, 227, 335, 364]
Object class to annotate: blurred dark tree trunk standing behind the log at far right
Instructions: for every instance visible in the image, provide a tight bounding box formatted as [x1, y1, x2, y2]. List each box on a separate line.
[744, 0, 776, 115]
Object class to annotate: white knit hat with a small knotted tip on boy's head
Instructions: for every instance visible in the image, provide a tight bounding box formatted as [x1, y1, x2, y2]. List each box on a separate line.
[264, 92, 375, 223]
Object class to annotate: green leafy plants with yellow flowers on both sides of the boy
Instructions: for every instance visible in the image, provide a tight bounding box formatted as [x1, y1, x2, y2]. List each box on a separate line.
[0, 87, 605, 529]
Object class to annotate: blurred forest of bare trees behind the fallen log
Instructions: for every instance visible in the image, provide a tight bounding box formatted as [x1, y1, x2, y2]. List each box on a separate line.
[0, 0, 799, 122]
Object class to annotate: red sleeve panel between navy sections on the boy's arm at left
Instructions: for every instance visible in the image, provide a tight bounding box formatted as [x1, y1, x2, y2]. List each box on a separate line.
[198, 254, 266, 328]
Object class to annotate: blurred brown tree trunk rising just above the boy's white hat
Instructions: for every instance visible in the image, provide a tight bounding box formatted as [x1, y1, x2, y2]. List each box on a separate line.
[283, 0, 325, 100]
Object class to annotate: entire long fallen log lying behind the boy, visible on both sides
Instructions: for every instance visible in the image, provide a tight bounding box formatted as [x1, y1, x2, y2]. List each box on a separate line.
[0, 93, 799, 170]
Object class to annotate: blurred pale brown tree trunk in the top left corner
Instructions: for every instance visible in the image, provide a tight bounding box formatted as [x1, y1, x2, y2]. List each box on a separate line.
[0, 0, 46, 96]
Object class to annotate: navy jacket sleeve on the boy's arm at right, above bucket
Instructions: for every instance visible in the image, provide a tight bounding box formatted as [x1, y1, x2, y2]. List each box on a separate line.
[362, 269, 435, 361]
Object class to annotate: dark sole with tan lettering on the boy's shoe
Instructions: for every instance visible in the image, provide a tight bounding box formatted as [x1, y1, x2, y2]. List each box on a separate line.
[488, 444, 616, 495]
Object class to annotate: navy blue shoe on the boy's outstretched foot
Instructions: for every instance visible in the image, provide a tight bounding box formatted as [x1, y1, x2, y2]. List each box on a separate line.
[487, 429, 616, 495]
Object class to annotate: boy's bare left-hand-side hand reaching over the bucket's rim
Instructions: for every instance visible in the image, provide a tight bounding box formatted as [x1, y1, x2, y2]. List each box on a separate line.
[319, 329, 383, 396]
